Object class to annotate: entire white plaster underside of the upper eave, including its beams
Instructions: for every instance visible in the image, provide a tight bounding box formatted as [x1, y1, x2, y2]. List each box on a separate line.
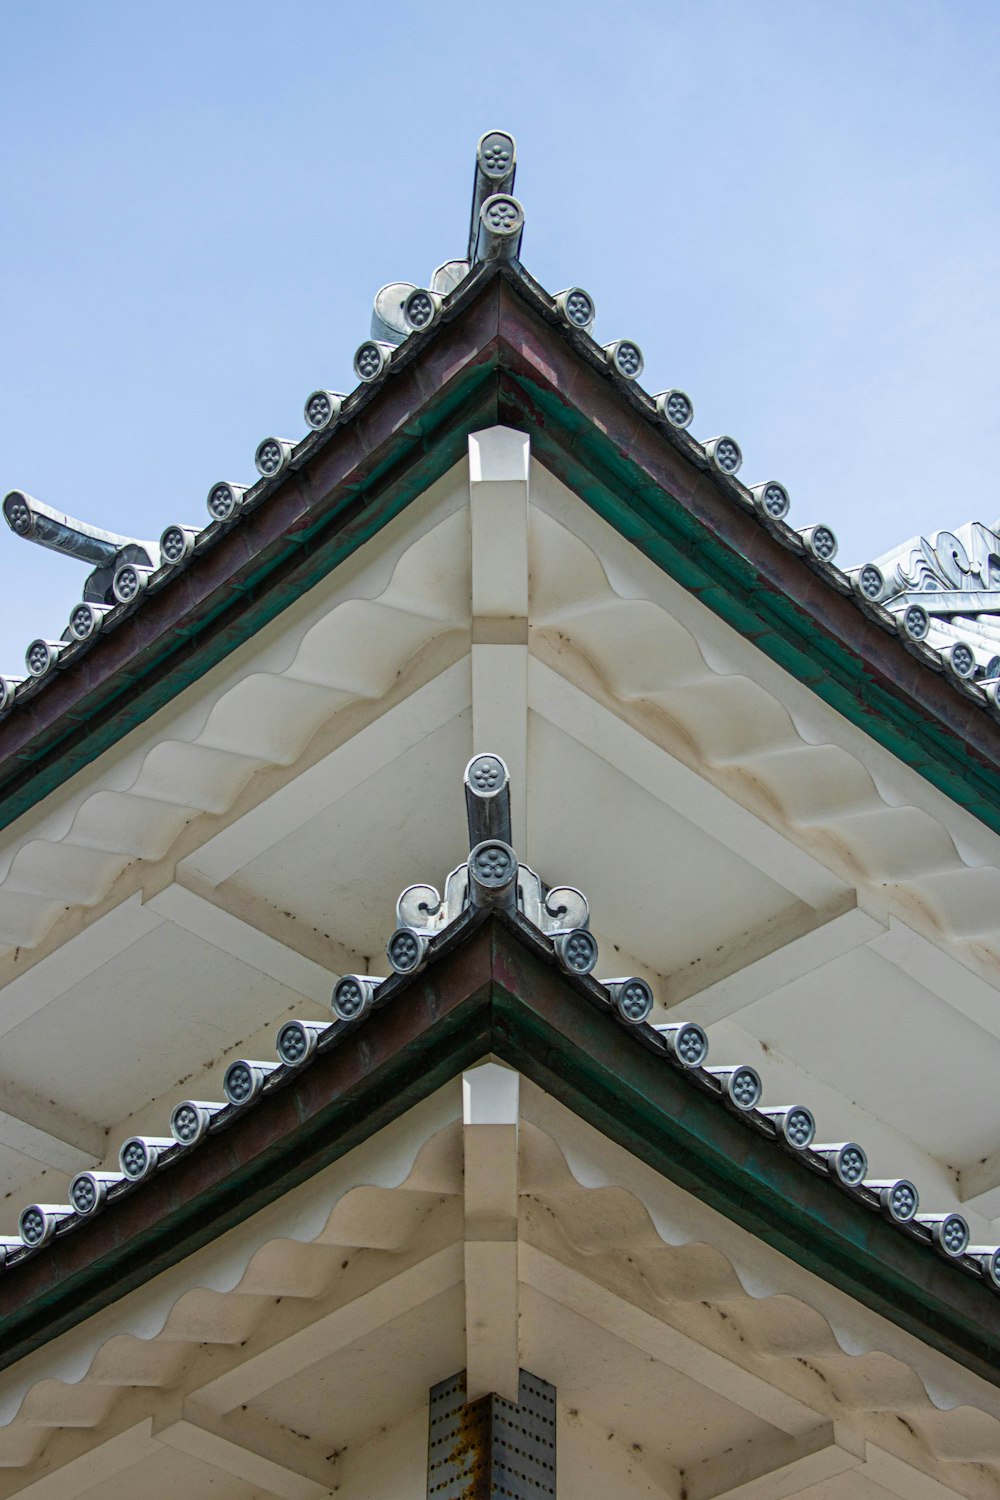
[0, 429, 1000, 1242]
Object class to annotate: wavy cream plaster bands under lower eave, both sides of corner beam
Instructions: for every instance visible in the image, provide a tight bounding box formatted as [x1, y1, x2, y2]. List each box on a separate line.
[0, 1086, 1000, 1494]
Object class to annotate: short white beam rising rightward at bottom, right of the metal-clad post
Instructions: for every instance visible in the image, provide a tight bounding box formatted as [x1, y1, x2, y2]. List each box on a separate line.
[684, 1422, 865, 1500]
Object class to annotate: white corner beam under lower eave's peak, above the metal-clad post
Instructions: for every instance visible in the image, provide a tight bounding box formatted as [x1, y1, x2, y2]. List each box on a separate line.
[462, 1062, 520, 1403]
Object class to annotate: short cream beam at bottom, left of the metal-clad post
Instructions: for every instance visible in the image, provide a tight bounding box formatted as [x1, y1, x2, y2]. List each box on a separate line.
[153, 1403, 336, 1500]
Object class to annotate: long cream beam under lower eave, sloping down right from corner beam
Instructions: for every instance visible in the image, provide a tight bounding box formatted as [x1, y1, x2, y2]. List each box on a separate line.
[520, 1244, 817, 1437]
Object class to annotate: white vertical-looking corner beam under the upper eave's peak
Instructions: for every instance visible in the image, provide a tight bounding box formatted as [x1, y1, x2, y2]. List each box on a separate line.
[469, 428, 531, 858]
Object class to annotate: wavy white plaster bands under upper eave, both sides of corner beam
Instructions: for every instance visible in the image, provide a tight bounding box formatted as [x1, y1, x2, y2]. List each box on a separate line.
[0, 429, 1000, 969]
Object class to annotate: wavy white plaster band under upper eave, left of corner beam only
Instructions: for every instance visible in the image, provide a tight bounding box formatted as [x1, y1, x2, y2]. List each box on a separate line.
[0, 465, 469, 948]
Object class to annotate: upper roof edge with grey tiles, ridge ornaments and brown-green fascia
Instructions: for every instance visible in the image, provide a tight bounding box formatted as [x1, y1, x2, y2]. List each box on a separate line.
[0, 131, 1000, 831]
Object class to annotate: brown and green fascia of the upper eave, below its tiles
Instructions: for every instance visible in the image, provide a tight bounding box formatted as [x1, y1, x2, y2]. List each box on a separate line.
[0, 263, 1000, 831]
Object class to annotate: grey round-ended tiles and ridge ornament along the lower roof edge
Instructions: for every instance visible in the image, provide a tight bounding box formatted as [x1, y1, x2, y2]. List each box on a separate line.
[0, 755, 1000, 1383]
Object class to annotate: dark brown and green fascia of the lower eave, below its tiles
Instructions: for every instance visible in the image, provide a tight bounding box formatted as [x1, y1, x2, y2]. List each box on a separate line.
[0, 914, 1000, 1385]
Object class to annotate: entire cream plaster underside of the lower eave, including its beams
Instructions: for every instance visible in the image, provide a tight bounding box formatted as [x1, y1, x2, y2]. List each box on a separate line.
[0, 1065, 1000, 1500]
